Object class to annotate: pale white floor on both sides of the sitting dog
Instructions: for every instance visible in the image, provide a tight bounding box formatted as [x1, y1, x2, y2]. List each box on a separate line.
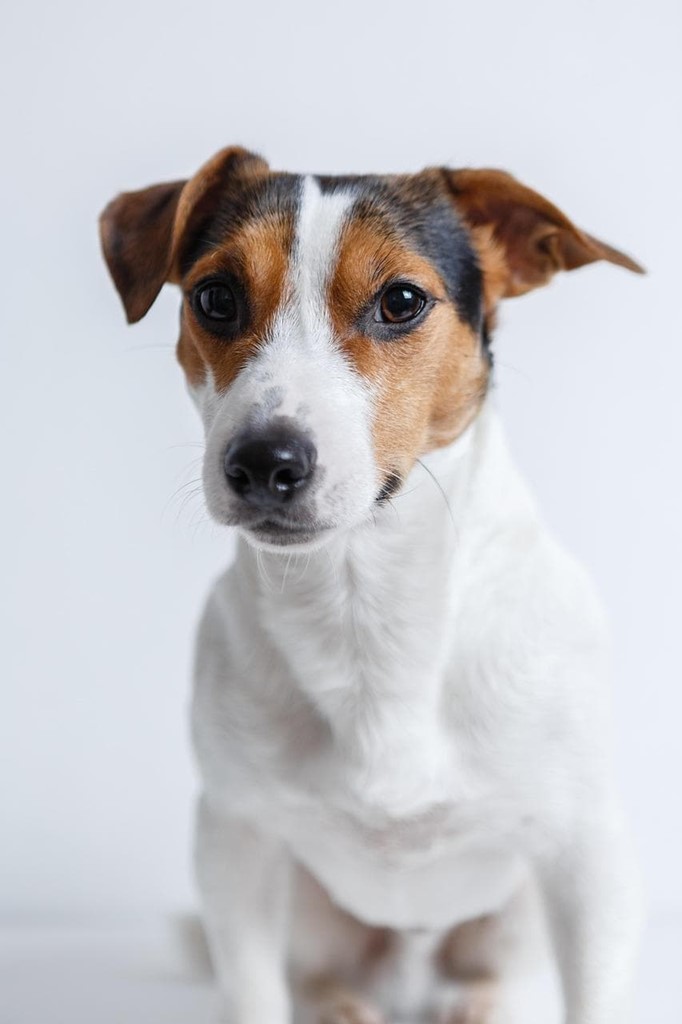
[0, 916, 682, 1024]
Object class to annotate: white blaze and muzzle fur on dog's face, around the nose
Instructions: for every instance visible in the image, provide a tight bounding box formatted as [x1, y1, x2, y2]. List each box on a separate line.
[195, 178, 381, 544]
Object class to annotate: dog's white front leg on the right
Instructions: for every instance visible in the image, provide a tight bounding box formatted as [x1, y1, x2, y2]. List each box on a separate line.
[540, 813, 641, 1024]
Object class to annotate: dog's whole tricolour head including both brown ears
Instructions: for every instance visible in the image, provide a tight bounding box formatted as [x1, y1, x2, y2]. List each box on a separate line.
[101, 148, 639, 550]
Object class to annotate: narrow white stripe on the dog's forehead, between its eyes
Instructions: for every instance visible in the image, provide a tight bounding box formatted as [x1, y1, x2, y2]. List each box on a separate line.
[291, 177, 354, 334]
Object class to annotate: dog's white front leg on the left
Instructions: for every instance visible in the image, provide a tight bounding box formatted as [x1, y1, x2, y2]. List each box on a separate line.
[197, 797, 291, 1024]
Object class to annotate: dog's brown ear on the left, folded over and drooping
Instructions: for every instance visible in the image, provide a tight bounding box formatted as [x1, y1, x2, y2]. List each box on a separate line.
[99, 146, 267, 324]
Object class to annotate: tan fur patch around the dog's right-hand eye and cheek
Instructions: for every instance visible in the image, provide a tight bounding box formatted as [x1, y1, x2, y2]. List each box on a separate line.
[329, 220, 488, 476]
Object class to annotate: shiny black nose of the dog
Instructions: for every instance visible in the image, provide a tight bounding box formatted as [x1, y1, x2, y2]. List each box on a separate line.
[224, 428, 316, 508]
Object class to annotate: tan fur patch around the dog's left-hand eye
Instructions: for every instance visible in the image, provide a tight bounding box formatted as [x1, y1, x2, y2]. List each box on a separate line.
[177, 217, 292, 391]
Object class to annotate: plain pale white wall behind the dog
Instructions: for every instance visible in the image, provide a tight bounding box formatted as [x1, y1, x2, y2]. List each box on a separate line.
[0, 0, 682, 922]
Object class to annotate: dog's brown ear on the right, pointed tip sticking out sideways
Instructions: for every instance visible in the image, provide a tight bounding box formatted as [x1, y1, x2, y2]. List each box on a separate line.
[444, 170, 645, 299]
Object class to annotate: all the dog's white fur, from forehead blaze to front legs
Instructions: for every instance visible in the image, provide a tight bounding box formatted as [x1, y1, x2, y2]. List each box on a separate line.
[188, 183, 638, 1024]
